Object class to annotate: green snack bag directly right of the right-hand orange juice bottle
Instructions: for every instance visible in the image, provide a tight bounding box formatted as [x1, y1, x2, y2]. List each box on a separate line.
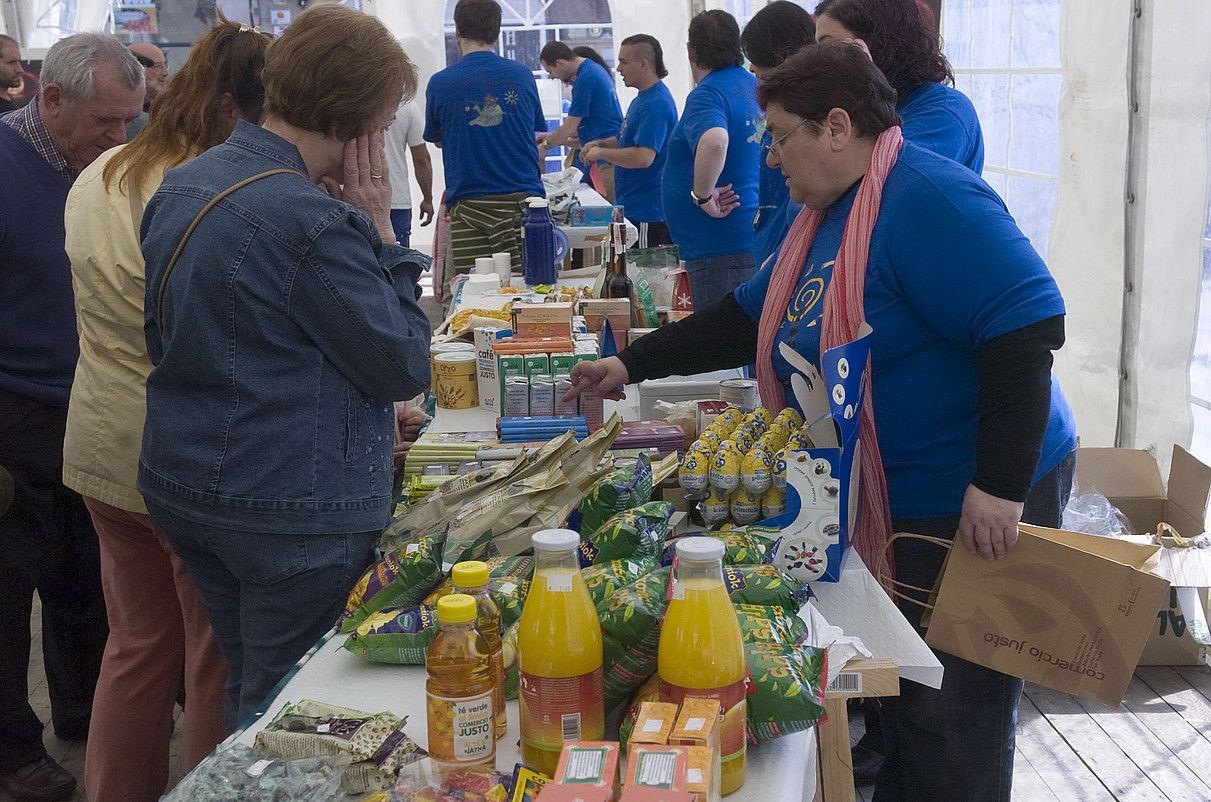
[745, 643, 828, 744]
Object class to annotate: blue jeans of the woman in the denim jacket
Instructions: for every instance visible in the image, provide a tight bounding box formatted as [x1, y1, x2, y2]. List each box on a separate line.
[148, 500, 379, 731]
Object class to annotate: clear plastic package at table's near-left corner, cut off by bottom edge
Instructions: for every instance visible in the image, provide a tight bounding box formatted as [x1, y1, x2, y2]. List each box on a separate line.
[162, 744, 349, 802]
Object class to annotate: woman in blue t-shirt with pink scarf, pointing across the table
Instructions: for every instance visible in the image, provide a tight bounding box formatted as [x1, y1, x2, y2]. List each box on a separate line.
[572, 44, 1077, 801]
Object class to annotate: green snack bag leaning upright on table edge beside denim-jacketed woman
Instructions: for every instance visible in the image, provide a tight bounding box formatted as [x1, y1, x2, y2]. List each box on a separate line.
[338, 535, 442, 632]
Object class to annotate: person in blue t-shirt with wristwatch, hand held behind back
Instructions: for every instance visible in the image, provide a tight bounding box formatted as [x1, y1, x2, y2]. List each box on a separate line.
[661, 11, 762, 310]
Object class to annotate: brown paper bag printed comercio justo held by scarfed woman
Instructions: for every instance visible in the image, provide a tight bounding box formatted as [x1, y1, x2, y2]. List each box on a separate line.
[925, 525, 1169, 706]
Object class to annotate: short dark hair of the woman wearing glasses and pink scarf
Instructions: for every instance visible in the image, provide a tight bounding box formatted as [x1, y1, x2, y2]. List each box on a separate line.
[757, 42, 900, 137]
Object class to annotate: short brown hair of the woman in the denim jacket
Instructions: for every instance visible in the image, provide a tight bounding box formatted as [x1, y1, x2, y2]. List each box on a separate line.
[262, 4, 417, 141]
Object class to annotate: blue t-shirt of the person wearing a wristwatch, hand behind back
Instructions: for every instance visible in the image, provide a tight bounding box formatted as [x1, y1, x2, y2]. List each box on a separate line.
[661, 67, 762, 259]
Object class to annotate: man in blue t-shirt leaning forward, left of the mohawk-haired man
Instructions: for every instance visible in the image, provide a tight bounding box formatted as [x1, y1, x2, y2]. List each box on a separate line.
[539, 41, 622, 204]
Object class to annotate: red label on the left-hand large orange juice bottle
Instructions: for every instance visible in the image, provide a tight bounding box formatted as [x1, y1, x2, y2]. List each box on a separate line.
[518, 669, 606, 755]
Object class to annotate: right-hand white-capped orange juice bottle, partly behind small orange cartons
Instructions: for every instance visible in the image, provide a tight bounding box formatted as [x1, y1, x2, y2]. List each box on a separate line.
[656, 538, 747, 794]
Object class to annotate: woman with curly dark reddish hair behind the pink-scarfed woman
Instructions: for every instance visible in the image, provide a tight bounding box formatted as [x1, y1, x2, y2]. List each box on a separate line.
[816, 0, 983, 173]
